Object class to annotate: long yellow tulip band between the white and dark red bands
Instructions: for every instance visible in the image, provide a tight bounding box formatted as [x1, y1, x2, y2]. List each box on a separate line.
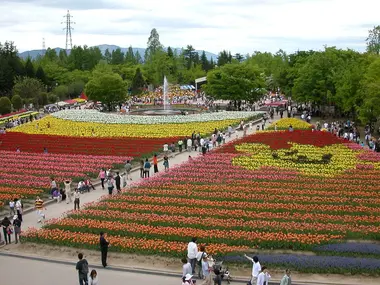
[9, 116, 240, 138]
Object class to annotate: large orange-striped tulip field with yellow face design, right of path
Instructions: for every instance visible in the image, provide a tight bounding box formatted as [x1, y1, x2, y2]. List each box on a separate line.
[23, 131, 380, 274]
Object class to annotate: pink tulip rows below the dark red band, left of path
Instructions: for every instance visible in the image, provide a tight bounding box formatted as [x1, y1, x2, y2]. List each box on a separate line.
[0, 151, 132, 206]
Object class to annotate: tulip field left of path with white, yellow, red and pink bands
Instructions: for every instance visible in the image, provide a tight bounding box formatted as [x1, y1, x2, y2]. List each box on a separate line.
[0, 110, 260, 207]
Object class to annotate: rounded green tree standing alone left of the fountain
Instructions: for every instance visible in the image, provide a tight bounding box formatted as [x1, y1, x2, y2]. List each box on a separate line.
[85, 72, 127, 110]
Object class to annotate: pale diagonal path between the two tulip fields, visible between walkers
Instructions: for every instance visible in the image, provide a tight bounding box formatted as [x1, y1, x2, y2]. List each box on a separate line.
[17, 113, 278, 230]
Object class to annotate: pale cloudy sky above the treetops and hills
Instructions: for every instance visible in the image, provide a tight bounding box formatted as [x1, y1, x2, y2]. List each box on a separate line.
[0, 0, 380, 54]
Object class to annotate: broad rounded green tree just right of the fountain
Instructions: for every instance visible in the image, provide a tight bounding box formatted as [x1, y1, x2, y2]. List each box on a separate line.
[202, 63, 265, 102]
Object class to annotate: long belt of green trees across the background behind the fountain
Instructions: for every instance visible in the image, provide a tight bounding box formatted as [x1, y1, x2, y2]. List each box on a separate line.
[0, 26, 380, 122]
